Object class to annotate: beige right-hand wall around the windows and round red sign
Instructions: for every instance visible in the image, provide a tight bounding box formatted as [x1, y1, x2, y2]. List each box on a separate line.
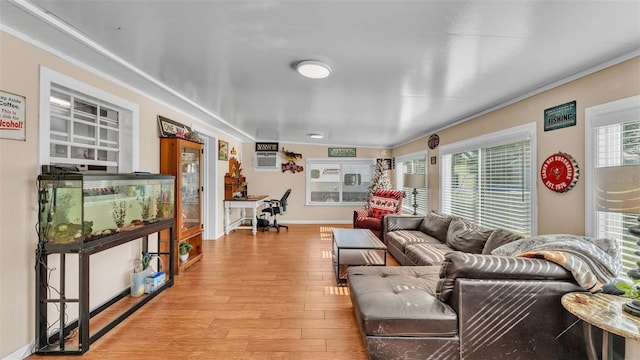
[393, 57, 640, 234]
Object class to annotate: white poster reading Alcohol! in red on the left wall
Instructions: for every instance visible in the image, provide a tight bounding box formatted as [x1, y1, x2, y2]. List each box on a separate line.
[0, 90, 27, 141]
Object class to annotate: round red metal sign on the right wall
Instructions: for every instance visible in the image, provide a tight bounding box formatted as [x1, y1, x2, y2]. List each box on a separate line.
[540, 152, 580, 193]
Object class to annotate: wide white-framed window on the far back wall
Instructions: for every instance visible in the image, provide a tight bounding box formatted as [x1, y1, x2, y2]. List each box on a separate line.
[305, 159, 375, 205]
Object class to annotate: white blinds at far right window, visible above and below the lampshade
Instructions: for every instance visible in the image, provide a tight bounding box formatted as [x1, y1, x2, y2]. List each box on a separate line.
[592, 120, 640, 277]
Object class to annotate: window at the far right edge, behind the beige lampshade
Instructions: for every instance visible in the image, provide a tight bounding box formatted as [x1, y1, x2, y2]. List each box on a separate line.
[585, 96, 640, 278]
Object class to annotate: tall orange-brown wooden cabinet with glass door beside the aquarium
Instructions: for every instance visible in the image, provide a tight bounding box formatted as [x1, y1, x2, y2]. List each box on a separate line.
[160, 138, 203, 274]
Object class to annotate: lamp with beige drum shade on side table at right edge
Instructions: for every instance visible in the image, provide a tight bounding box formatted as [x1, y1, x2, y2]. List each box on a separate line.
[595, 165, 640, 316]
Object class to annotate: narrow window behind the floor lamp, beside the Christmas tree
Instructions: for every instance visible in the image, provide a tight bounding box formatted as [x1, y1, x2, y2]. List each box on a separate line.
[396, 152, 428, 215]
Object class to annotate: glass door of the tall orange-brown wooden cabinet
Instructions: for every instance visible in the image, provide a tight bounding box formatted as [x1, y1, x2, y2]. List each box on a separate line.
[176, 146, 201, 235]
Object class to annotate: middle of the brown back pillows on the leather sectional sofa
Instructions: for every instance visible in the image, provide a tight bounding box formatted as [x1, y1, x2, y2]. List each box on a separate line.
[446, 218, 494, 254]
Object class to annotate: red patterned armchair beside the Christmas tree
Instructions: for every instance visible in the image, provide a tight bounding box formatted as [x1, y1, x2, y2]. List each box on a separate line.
[353, 190, 405, 241]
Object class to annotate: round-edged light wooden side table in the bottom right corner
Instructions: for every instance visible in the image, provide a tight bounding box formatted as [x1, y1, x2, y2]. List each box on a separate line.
[562, 292, 640, 360]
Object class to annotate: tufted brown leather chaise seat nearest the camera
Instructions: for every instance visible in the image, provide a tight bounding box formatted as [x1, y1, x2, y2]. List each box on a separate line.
[348, 266, 458, 337]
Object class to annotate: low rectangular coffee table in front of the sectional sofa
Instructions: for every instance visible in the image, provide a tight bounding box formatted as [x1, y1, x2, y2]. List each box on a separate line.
[332, 229, 387, 286]
